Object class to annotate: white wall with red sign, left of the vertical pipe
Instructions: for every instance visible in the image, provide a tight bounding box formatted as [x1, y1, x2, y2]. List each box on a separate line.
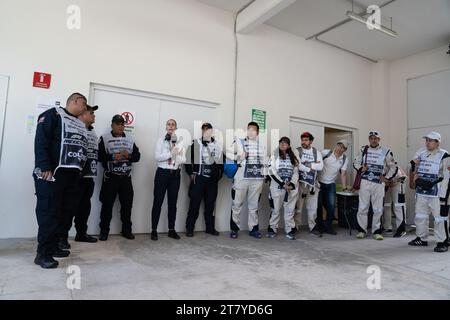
[0, 0, 234, 238]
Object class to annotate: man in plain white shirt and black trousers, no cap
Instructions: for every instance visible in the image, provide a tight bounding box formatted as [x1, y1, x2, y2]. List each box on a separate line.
[151, 119, 186, 241]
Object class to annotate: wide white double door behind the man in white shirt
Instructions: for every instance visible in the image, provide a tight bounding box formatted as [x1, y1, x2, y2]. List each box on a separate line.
[85, 85, 216, 234]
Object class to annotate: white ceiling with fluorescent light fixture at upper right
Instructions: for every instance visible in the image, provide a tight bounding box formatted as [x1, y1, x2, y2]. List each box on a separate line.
[199, 0, 450, 60]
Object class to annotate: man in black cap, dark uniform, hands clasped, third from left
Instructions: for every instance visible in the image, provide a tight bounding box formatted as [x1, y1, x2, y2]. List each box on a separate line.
[98, 115, 141, 241]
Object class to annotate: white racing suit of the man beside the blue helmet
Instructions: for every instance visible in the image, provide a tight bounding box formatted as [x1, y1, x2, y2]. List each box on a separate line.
[227, 138, 267, 231]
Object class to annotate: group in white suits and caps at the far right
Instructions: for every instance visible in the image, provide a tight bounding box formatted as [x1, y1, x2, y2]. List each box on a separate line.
[354, 131, 450, 252]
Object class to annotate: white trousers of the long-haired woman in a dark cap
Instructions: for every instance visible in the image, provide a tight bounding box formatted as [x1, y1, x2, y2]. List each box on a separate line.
[269, 182, 298, 233]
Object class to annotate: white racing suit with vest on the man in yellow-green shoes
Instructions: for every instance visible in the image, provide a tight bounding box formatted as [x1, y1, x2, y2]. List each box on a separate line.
[353, 146, 398, 234]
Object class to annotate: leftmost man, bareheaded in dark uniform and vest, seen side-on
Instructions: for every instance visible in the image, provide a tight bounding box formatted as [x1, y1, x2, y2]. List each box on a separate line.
[33, 93, 87, 269]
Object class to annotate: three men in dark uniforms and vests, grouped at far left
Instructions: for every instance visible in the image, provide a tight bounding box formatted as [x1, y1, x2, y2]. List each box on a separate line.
[33, 93, 140, 269]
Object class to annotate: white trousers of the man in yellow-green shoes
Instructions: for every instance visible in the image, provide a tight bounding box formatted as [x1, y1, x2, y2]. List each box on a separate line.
[357, 179, 384, 234]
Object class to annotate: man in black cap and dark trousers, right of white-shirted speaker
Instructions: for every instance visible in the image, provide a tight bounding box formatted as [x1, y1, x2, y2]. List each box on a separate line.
[184, 123, 223, 237]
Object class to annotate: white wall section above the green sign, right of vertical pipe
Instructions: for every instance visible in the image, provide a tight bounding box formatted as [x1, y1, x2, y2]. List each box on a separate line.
[236, 25, 372, 149]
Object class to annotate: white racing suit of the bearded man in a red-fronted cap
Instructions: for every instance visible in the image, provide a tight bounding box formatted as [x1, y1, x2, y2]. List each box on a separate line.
[294, 147, 323, 231]
